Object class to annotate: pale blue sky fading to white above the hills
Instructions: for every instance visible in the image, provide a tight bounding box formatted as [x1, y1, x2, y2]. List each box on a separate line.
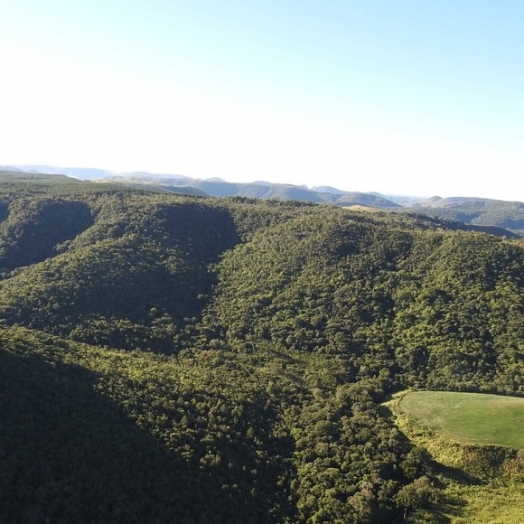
[0, 0, 524, 201]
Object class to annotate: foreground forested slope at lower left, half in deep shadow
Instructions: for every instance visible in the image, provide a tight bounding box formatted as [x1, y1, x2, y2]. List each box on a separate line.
[0, 328, 297, 524]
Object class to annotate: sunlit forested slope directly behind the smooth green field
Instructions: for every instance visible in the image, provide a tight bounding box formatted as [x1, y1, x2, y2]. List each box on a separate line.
[195, 209, 524, 392]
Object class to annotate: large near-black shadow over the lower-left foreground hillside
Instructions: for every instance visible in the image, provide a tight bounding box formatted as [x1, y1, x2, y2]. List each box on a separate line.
[0, 349, 293, 524]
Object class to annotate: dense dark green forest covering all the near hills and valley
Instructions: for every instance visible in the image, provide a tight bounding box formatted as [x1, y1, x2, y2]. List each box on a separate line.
[0, 175, 524, 524]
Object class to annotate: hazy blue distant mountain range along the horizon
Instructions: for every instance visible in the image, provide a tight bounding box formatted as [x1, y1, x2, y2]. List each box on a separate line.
[0, 165, 524, 235]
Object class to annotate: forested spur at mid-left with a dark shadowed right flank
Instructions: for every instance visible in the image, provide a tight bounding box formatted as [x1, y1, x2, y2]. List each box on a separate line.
[0, 196, 238, 351]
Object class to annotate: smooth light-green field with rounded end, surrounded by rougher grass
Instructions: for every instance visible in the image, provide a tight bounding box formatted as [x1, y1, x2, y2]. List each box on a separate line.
[400, 391, 524, 449]
